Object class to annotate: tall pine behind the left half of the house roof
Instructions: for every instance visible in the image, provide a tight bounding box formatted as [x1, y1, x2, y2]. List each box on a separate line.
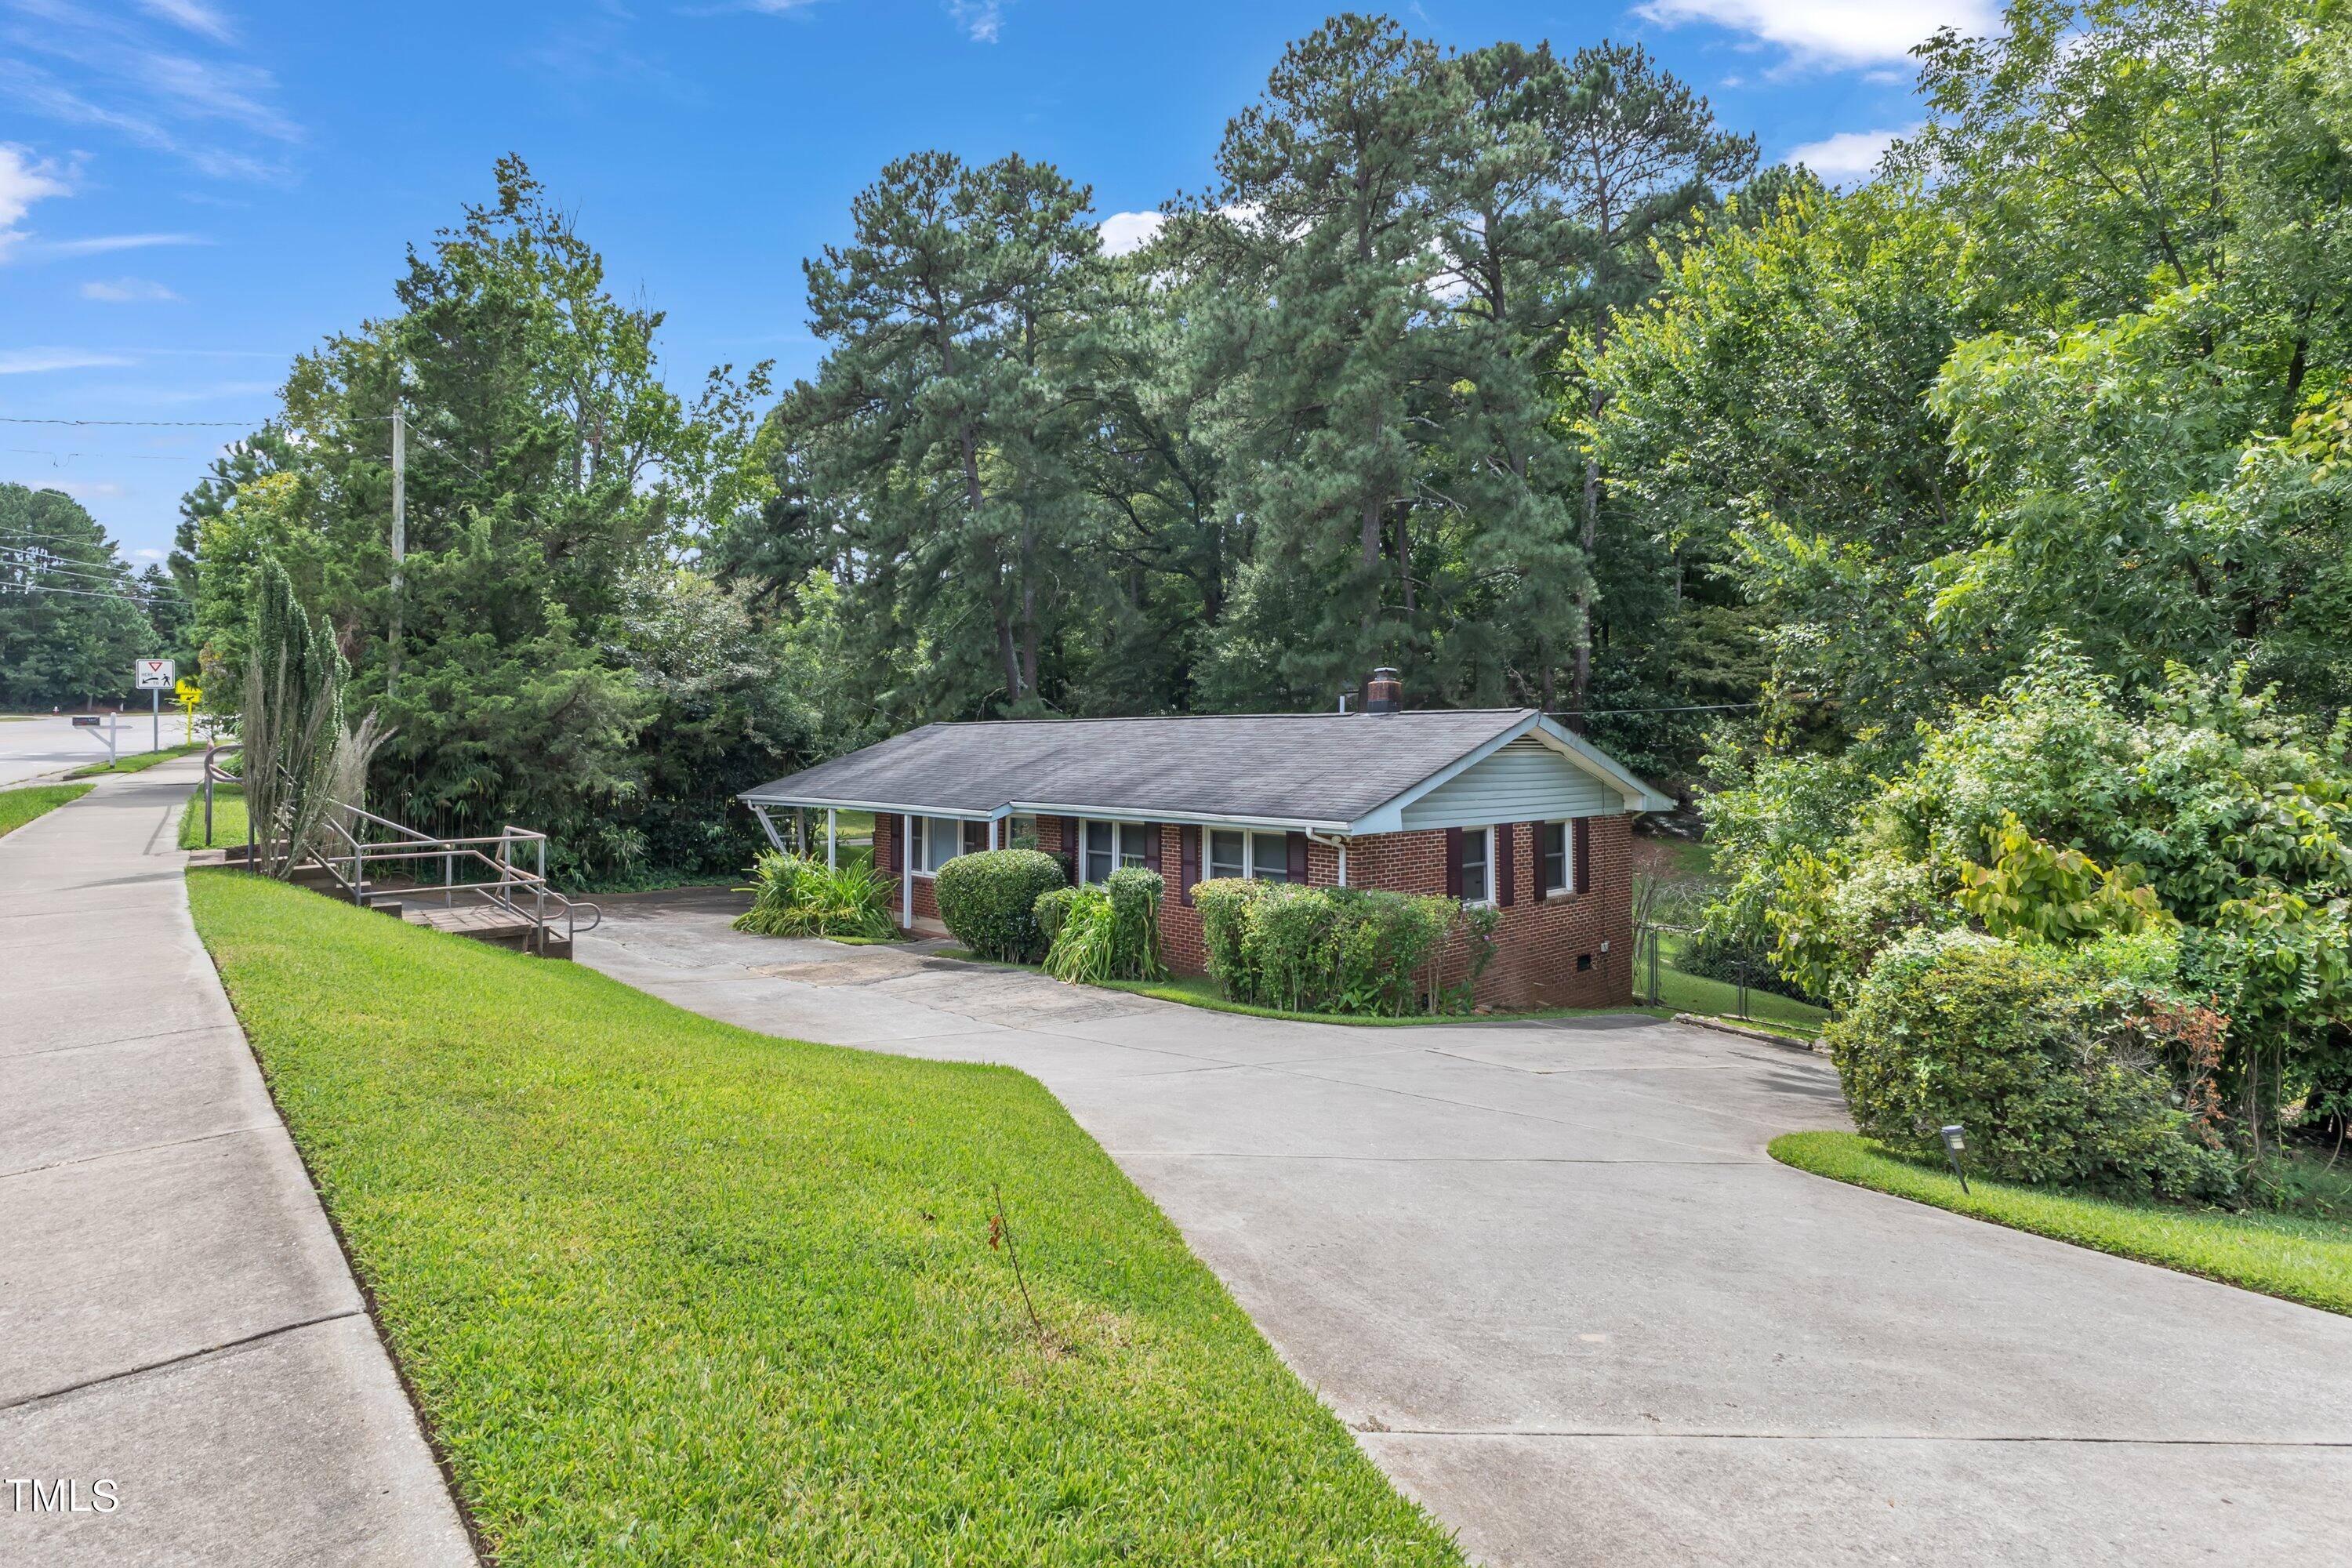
[779, 153, 1101, 710]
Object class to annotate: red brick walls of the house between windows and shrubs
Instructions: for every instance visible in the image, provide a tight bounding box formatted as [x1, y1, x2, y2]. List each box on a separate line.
[875, 815, 1632, 1008]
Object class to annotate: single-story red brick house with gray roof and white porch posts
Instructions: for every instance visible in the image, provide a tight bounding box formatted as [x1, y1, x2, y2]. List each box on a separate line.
[741, 670, 1672, 1008]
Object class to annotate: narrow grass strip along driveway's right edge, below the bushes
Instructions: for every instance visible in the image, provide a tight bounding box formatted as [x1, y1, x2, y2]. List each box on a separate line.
[1769, 1133, 2352, 1314]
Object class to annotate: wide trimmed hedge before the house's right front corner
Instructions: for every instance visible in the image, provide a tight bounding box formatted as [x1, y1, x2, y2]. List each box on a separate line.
[1192, 877, 1468, 1018]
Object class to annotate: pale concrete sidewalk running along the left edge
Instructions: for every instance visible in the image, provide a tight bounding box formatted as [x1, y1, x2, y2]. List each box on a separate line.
[0, 762, 475, 1566]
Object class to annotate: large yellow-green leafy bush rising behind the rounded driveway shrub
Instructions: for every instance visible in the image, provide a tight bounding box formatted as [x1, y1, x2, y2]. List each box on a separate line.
[1712, 647, 2352, 1147]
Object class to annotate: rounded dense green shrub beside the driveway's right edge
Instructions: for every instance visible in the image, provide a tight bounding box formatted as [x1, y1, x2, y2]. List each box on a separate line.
[1823, 931, 2234, 1196]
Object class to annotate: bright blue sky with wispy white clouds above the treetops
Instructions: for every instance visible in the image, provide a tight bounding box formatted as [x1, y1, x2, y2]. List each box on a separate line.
[0, 0, 1990, 560]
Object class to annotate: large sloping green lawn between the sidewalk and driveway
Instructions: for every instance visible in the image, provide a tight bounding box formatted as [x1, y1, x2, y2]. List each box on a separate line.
[188, 872, 1461, 1568]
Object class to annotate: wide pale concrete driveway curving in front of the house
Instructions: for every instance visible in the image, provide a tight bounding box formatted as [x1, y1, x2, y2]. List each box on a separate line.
[579, 893, 2352, 1568]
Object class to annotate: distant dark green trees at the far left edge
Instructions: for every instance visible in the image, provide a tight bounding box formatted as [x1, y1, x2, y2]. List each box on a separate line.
[0, 485, 183, 710]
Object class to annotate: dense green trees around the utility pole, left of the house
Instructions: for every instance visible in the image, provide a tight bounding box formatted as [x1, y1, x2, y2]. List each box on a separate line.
[176, 160, 823, 877]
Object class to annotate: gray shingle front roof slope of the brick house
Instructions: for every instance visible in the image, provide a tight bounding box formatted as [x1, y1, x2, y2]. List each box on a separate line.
[743, 708, 1529, 822]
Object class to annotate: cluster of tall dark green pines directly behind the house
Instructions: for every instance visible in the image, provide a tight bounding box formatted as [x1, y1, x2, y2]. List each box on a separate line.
[720, 16, 1757, 780]
